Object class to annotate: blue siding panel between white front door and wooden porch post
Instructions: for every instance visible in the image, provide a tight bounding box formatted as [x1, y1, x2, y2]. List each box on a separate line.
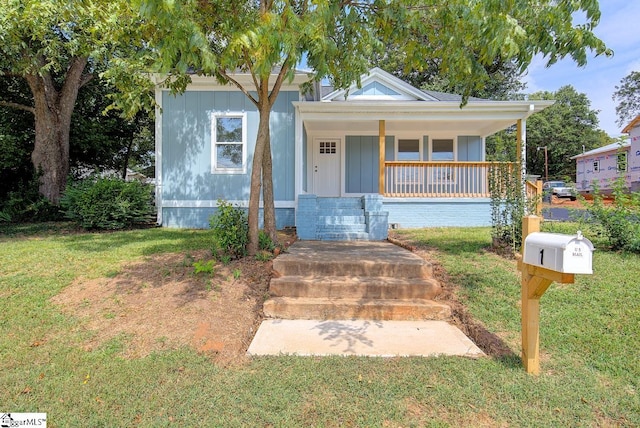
[345, 135, 380, 193]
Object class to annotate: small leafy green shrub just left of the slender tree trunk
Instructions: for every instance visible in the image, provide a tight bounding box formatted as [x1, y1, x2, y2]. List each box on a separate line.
[209, 199, 249, 258]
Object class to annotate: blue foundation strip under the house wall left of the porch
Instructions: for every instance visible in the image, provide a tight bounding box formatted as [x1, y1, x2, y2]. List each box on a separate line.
[162, 208, 295, 229]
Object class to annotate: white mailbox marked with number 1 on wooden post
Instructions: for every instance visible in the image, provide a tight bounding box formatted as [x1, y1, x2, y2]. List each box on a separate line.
[523, 231, 593, 274]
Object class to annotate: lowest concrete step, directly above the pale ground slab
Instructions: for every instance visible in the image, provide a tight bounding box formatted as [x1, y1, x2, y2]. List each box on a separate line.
[263, 297, 451, 320]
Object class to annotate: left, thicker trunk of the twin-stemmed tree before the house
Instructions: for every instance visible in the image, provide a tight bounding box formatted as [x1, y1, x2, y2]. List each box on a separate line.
[247, 102, 271, 256]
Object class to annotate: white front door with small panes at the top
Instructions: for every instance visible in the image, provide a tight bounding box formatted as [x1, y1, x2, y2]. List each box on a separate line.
[312, 138, 340, 197]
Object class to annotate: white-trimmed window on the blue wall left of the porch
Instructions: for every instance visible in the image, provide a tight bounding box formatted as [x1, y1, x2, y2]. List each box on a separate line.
[211, 113, 247, 174]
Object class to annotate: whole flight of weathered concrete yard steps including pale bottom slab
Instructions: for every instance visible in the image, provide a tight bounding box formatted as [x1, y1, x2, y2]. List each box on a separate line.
[247, 241, 484, 357]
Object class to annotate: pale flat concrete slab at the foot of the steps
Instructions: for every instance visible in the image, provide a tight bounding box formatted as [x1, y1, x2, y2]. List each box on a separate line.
[247, 319, 484, 358]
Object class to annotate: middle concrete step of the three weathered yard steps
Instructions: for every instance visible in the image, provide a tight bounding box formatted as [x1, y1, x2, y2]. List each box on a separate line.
[269, 275, 441, 299]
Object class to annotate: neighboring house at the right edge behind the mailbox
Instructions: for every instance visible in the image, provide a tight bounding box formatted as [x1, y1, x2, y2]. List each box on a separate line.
[571, 115, 640, 195]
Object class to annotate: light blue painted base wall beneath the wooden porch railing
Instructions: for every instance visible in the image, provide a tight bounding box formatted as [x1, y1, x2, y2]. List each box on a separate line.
[383, 198, 491, 228]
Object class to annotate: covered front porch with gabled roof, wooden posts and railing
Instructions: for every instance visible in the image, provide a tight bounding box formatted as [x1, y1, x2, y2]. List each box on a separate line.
[294, 69, 553, 235]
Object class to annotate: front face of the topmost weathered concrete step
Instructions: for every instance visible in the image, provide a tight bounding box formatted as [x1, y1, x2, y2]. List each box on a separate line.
[273, 256, 433, 278]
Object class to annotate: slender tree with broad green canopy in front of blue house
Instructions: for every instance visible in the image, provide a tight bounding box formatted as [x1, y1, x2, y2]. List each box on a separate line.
[123, 0, 610, 253]
